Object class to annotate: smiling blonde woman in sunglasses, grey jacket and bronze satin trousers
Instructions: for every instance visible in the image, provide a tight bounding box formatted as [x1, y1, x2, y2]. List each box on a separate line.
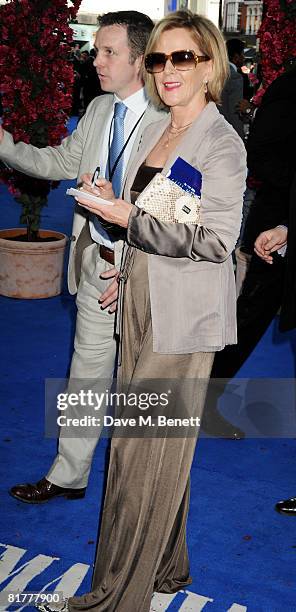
[40, 11, 245, 612]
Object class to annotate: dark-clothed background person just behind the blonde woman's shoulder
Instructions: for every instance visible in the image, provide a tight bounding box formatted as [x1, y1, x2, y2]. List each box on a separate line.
[219, 38, 245, 139]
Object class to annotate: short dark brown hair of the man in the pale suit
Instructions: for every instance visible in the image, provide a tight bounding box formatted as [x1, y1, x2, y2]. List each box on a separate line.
[98, 11, 154, 63]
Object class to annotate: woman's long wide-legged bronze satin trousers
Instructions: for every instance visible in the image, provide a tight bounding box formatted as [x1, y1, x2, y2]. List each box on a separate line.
[69, 250, 214, 612]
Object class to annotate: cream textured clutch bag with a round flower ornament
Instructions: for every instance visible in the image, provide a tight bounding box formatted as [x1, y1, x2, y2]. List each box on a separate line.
[136, 172, 201, 225]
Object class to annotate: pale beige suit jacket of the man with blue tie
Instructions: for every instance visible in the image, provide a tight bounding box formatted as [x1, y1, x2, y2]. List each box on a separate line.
[0, 95, 163, 293]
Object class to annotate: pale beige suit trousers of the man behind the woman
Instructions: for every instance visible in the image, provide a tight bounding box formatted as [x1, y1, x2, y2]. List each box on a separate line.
[46, 243, 116, 489]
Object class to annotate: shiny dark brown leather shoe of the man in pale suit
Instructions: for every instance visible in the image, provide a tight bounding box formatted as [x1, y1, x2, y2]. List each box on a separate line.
[9, 478, 85, 504]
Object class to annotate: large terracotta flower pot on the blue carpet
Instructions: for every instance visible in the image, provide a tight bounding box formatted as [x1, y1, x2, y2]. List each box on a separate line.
[0, 228, 67, 299]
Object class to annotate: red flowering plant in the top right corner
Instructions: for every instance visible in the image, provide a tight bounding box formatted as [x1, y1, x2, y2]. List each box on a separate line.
[258, 0, 296, 94]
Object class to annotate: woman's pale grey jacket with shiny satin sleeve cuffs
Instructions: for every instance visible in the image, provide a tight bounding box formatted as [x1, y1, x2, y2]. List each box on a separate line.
[125, 102, 246, 354]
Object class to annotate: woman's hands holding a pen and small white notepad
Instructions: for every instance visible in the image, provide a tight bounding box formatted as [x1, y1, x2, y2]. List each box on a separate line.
[75, 174, 133, 228]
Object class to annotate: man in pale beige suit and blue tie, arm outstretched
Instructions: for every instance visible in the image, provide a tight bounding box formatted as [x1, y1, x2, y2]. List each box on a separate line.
[0, 11, 160, 503]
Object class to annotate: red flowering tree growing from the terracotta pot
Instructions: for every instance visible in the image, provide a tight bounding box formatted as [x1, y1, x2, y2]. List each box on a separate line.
[0, 0, 81, 240]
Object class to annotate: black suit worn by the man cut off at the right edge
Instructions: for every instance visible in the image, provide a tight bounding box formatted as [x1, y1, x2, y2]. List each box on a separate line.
[207, 60, 296, 436]
